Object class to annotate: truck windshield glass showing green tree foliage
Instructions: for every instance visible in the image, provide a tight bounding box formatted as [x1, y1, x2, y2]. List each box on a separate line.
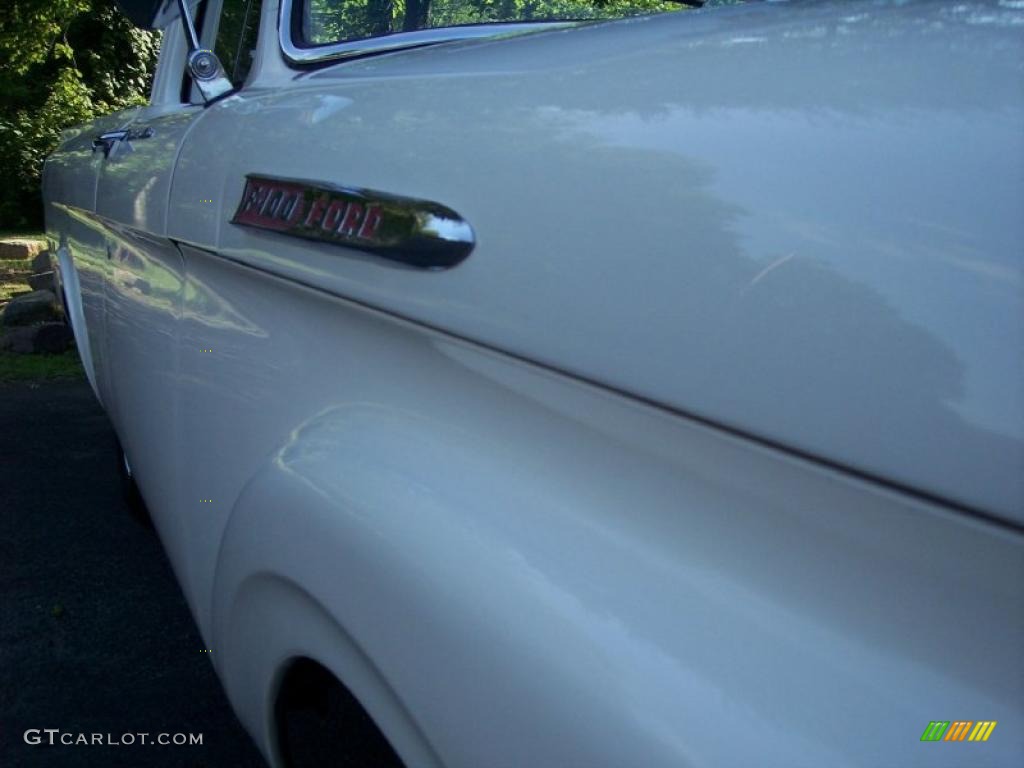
[301, 0, 708, 46]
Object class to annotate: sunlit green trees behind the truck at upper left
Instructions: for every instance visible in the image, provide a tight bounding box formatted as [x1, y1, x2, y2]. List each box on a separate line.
[0, 0, 160, 228]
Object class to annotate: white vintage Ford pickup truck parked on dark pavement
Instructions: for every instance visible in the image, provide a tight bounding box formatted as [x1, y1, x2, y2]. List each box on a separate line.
[44, 0, 1024, 768]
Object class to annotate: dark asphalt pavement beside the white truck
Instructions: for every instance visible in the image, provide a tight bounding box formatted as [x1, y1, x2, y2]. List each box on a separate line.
[0, 381, 264, 768]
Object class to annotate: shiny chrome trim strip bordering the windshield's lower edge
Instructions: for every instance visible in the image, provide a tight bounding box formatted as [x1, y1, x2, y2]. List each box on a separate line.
[278, 0, 579, 65]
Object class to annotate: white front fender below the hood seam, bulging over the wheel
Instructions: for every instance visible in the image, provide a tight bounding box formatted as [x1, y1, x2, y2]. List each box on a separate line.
[190, 241, 1024, 768]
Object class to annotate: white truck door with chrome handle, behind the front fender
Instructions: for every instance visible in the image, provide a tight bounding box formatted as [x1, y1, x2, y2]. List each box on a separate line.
[95, 19, 197, 577]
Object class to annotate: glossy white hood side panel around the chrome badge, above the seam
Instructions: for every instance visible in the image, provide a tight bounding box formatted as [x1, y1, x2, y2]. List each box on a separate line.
[169, 2, 1024, 521]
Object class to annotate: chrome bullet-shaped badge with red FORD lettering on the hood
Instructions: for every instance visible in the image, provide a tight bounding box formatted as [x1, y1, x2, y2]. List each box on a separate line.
[231, 175, 474, 268]
